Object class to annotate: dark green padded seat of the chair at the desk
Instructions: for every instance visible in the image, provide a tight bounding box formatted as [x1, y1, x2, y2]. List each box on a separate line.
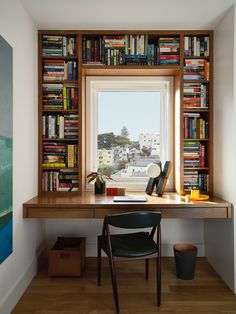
[99, 232, 157, 258]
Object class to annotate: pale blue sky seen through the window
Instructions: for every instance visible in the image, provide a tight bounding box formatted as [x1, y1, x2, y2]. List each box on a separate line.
[98, 91, 160, 141]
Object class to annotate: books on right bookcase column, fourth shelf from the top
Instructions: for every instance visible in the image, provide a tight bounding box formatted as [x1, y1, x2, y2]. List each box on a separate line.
[183, 112, 208, 139]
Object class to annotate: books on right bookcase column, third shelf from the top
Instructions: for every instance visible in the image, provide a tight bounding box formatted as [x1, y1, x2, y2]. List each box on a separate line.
[183, 82, 209, 108]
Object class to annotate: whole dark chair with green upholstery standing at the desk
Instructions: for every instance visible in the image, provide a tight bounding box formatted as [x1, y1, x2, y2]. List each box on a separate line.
[97, 212, 161, 313]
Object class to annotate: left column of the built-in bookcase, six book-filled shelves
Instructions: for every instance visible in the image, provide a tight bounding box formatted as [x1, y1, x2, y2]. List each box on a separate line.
[39, 31, 80, 193]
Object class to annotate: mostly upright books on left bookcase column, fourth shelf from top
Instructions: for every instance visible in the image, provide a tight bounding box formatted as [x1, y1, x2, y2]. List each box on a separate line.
[43, 114, 78, 139]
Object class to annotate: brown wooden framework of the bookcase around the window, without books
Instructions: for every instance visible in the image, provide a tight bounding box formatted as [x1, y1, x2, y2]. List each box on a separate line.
[38, 30, 213, 195]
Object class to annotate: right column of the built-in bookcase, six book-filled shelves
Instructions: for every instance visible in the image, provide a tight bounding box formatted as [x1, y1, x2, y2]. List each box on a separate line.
[181, 32, 213, 194]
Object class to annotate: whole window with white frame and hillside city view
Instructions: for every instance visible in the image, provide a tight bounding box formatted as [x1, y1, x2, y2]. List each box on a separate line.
[86, 77, 173, 190]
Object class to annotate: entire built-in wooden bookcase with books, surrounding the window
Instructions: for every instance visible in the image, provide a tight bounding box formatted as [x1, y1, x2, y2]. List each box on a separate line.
[39, 30, 213, 194]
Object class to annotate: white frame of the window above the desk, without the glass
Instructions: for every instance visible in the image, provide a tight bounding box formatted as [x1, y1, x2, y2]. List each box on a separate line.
[85, 76, 174, 191]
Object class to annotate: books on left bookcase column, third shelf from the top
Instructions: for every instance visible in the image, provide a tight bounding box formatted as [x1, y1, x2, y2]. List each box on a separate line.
[43, 83, 78, 110]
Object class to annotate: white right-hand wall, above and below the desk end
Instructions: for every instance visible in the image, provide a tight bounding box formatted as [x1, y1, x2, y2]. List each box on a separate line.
[205, 7, 236, 292]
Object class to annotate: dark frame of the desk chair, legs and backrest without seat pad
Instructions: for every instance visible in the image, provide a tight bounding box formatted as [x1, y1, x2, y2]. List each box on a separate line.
[97, 212, 161, 313]
